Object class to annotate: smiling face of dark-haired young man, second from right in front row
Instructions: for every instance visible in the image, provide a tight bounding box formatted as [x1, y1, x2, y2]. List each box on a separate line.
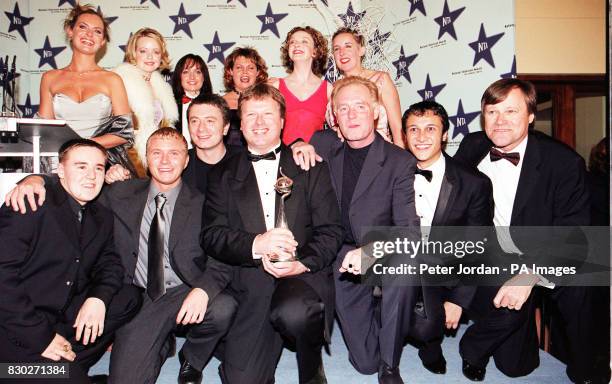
[406, 111, 448, 169]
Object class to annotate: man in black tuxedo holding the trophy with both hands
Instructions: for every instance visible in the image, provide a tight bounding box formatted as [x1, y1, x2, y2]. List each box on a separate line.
[202, 84, 341, 384]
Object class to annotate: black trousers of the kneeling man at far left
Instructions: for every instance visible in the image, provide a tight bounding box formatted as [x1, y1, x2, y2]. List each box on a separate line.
[0, 285, 141, 383]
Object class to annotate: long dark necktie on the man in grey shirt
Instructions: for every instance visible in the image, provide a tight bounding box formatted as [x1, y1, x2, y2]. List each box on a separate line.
[147, 193, 166, 301]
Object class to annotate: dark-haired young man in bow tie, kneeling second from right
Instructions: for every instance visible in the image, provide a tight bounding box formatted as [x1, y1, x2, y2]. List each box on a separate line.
[402, 101, 493, 374]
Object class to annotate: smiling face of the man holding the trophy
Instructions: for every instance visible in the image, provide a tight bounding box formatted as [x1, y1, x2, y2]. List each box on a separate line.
[240, 97, 284, 154]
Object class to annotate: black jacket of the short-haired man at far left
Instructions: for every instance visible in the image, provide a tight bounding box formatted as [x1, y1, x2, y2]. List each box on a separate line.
[0, 184, 123, 353]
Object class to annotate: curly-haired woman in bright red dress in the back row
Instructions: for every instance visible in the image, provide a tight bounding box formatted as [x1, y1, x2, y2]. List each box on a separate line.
[270, 26, 332, 145]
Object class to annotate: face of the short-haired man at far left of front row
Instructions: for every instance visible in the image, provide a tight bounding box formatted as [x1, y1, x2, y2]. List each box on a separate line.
[57, 146, 106, 205]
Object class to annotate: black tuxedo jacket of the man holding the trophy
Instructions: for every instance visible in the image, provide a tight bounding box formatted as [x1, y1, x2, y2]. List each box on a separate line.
[202, 146, 342, 367]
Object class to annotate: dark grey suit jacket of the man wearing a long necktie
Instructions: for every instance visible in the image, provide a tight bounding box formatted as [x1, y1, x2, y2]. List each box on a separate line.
[99, 179, 230, 301]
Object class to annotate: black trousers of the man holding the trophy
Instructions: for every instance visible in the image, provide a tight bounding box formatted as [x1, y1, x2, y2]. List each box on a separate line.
[219, 278, 325, 384]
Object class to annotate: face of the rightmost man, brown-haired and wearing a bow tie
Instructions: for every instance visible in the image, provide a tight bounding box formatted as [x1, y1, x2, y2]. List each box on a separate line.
[483, 88, 535, 152]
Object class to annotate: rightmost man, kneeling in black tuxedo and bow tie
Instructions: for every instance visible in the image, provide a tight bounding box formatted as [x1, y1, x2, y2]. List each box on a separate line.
[455, 79, 593, 382]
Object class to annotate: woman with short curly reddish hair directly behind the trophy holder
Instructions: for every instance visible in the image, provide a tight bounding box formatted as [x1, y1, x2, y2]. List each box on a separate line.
[223, 47, 268, 146]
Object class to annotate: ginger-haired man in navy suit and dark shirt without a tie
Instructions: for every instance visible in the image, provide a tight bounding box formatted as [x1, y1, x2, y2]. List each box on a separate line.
[310, 77, 419, 383]
